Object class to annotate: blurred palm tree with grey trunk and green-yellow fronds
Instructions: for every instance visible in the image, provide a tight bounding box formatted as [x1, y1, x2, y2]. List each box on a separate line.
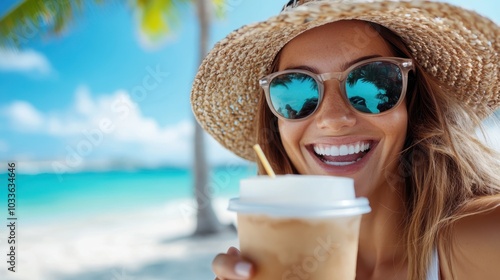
[0, 0, 224, 235]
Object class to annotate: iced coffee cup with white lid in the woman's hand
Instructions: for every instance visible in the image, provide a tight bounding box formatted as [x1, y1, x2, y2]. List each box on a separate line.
[229, 175, 370, 280]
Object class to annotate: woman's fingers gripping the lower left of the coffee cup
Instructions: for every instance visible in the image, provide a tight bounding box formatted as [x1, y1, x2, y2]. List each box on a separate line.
[212, 247, 253, 280]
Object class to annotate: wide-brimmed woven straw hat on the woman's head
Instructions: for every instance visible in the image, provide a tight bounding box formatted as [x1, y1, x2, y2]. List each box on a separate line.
[191, 0, 500, 161]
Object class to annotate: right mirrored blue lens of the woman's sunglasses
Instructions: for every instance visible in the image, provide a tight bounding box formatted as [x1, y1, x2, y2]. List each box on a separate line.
[345, 62, 403, 114]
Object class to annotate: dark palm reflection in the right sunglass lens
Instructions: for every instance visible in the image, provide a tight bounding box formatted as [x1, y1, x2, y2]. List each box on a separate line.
[347, 62, 403, 112]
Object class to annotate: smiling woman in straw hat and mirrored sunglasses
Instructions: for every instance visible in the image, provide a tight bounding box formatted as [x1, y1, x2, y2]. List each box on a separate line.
[192, 1, 500, 280]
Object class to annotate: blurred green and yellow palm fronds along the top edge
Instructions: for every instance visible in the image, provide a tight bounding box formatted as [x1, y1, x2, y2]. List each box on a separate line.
[0, 0, 226, 48]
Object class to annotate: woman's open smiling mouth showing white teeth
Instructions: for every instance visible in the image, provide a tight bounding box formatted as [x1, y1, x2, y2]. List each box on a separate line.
[313, 141, 372, 166]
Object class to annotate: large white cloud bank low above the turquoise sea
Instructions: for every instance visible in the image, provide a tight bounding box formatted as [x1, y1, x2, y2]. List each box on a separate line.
[2, 87, 243, 169]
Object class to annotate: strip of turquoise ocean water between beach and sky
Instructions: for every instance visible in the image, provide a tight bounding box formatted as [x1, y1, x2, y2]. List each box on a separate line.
[0, 166, 256, 223]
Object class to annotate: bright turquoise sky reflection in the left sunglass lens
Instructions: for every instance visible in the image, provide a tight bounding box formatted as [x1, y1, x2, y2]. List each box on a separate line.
[270, 75, 318, 117]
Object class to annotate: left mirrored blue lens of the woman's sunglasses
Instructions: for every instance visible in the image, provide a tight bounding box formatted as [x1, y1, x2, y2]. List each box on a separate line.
[269, 73, 319, 119]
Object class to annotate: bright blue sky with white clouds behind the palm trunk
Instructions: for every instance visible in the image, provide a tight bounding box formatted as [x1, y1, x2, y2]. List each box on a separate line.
[0, 0, 500, 172]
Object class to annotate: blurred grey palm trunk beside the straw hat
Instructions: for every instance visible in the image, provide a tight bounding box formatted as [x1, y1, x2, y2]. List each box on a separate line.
[194, 0, 221, 235]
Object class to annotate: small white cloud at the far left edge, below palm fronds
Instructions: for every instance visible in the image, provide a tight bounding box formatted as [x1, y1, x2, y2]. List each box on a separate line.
[0, 49, 52, 75]
